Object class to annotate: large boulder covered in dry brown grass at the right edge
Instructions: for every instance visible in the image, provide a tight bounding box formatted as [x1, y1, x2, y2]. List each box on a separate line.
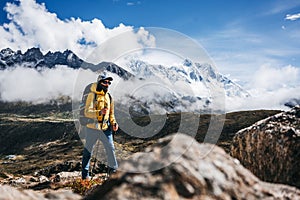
[231, 107, 300, 188]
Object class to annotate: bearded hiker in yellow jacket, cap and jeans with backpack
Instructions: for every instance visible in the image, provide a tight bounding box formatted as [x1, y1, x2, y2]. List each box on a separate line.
[82, 74, 118, 179]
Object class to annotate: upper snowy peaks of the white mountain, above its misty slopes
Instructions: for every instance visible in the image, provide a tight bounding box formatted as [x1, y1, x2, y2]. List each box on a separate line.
[126, 59, 250, 97]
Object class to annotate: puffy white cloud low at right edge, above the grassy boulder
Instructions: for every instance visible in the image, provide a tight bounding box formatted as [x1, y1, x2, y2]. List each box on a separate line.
[226, 66, 300, 111]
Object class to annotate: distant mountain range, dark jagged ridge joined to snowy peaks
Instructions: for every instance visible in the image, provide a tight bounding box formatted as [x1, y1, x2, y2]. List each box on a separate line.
[0, 48, 250, 111]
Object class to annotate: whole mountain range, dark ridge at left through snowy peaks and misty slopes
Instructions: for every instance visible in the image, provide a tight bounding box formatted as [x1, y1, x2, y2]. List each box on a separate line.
[0, 48, 249, 113]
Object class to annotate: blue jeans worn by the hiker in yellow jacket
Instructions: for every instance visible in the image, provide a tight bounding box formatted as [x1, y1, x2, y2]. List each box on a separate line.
[81, 127, 118, 179]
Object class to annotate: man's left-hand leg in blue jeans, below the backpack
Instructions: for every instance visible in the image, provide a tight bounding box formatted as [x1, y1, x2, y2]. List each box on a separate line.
[81, 127, 99, 179]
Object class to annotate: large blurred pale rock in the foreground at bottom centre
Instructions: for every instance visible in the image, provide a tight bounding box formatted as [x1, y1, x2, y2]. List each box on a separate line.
[85, 134, 300, 200]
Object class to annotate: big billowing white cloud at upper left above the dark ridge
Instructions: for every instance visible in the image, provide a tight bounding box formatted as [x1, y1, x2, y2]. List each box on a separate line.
[0, 0, 154, 63]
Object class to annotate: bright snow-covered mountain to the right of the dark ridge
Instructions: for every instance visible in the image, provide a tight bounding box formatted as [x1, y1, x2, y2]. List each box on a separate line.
[118, 59, 250, 111]
